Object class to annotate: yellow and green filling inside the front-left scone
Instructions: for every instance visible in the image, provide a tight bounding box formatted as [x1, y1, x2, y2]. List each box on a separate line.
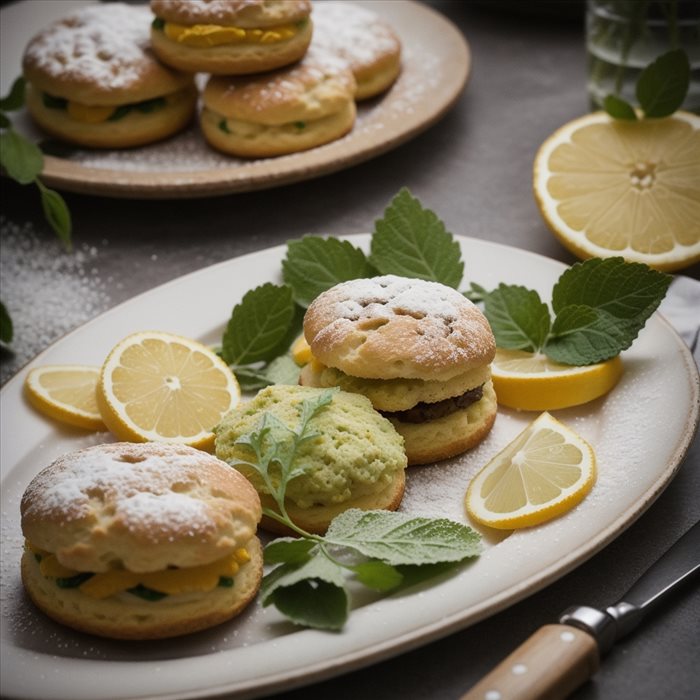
[26, 542, 250, 600]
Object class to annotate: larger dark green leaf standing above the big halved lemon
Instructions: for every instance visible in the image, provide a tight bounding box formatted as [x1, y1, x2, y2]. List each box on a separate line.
[636, 49, 690, 118]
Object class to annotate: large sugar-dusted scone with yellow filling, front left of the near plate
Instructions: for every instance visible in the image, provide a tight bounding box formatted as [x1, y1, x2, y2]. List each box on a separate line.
[21, 443, 262, 639]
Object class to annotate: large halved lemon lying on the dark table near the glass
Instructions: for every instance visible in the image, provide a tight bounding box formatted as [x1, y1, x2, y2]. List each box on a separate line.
[534, 112, 700, 270]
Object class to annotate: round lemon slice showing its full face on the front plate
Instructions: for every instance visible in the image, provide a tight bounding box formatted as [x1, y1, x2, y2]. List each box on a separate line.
[97, 331, 240, 449]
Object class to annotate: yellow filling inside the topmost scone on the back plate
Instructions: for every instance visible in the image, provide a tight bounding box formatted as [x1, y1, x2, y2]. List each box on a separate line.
[160, 22, 304, 48]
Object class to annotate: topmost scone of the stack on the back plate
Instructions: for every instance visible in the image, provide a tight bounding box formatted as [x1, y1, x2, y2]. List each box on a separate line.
[151, 0, 313, 75]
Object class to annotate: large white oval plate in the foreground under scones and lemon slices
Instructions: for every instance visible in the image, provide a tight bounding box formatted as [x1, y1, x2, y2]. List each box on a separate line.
[0, 234, 700, 700]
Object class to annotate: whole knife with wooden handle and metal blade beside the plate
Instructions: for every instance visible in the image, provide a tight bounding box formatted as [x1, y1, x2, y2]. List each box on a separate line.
[462, 522, 700, 700]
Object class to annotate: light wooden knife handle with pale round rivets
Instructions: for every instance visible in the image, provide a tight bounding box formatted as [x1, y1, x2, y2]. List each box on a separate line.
[462, 625, 599, 700]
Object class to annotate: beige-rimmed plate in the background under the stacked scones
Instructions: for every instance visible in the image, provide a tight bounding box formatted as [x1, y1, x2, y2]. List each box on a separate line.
[0, 0, 471, 199]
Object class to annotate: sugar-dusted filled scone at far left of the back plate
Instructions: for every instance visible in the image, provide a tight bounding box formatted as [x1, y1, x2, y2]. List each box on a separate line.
[22, 3, 197, 148]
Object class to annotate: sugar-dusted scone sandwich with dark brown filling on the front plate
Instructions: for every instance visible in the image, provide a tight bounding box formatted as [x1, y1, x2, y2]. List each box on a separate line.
[301, 275, 497, 464]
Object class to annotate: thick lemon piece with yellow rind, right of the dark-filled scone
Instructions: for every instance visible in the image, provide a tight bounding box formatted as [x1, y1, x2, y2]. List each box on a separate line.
[491, 348, 623, 411]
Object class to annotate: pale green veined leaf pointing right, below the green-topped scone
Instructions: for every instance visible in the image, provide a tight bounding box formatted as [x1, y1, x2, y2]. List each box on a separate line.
[325, 508, 481, 566]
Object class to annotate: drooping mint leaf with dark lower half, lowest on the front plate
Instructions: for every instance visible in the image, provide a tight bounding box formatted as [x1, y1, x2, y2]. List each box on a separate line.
[260, 548, 350, 630]
